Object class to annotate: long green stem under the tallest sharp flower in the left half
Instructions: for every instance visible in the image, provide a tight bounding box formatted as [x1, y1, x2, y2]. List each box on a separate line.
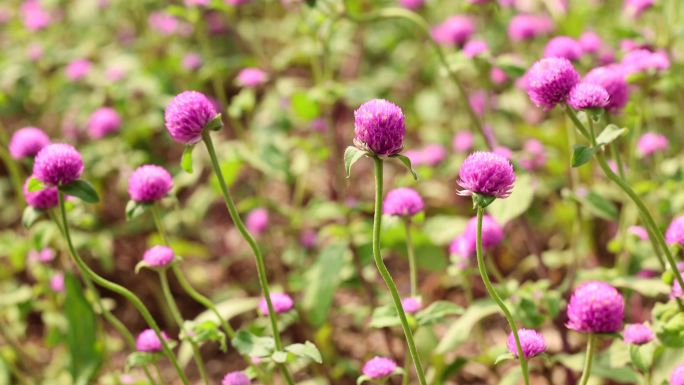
[202, 130, 294, 385]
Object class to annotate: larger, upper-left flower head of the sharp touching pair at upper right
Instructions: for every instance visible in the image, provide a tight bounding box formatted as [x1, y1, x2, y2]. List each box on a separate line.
[526, 58, 579, 109]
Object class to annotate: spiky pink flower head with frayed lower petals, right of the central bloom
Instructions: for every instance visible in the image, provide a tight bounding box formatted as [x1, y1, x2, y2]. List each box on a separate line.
[458, 151, 515, 198]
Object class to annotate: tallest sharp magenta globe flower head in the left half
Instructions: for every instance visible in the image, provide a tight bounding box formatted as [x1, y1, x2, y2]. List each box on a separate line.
[164, 91, 218, 144]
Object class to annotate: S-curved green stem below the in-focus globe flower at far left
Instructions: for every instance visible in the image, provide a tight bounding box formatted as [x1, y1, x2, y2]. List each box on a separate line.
[57, 191, 189, 385]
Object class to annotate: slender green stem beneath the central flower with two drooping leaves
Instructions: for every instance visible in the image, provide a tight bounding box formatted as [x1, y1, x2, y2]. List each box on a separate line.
[373, 157, 427, 385]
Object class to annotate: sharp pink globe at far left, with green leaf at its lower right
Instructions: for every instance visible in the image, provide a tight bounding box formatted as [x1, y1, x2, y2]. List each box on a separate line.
[33, 143, 83, 186]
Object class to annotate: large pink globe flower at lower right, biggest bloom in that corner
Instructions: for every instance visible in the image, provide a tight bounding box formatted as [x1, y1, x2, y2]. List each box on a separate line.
[566, 281, 625, 333]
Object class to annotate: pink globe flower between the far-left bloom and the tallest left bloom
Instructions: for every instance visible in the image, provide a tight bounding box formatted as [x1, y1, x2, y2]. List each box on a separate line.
[128, 164, 173, 202]
